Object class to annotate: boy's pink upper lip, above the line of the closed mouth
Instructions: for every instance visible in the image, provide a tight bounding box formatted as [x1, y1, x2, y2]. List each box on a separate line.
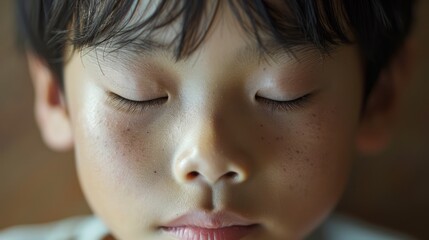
[162, 211, 256, 229]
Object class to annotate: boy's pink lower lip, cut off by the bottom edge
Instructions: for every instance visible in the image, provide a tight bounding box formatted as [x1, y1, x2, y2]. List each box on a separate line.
[163, 225, 256, 240]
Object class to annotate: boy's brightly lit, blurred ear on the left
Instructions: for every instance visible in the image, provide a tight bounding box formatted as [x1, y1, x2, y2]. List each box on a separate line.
[27, 53, 73, 151]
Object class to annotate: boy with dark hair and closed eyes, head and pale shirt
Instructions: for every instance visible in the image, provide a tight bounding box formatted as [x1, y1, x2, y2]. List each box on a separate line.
[0, 0, 412, 240]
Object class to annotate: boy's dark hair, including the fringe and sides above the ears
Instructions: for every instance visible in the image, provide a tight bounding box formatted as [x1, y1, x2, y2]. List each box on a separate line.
[17, 0, 414, 102]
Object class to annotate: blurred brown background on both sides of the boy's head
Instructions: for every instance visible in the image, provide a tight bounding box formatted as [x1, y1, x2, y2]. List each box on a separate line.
[0, 0, 429, 239]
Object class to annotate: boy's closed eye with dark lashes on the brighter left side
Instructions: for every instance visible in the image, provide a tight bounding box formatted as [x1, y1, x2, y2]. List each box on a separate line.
[108, 92, 168, 113]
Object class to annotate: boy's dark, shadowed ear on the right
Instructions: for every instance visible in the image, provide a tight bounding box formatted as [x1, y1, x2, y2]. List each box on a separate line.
[357, 39, 414, 155]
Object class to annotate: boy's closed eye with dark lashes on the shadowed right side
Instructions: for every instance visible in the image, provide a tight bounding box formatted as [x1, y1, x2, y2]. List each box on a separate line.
[255, 94, 311, 112]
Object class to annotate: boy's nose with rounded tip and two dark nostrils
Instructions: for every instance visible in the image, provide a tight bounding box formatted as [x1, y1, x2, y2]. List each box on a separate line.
[173, 115, 250, 185]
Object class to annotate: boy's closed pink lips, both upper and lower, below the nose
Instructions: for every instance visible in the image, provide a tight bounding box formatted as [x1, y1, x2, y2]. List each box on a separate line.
[161, 212, 258, 240]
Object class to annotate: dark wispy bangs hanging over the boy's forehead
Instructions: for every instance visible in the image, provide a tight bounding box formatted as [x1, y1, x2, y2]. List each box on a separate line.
[69, 0, 350, 59]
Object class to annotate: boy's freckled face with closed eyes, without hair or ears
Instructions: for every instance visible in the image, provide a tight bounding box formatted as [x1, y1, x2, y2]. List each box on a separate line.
[56, 4, 363, 239]
